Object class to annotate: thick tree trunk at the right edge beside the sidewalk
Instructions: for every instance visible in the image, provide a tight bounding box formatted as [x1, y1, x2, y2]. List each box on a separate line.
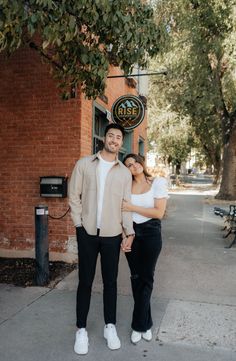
[216, 122, 236, 200]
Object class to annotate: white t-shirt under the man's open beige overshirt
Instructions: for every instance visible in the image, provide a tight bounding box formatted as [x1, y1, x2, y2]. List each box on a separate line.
[97, 155, 115, 228]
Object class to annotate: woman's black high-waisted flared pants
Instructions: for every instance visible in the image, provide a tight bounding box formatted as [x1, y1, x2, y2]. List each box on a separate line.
[126, 219, 162, 332]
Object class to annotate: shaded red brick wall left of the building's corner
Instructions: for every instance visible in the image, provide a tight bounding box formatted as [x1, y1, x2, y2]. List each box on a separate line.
[0, 45, 81, 251]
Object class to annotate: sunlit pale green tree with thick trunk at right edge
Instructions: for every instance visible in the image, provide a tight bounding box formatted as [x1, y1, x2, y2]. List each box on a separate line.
[149, 0, 236, 198]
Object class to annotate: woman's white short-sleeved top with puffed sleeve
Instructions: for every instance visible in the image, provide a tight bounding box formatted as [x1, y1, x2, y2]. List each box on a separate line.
[131, 177, 169, 223]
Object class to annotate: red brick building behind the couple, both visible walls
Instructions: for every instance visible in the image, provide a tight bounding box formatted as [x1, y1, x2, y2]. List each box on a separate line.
[0, 48, 146, 261]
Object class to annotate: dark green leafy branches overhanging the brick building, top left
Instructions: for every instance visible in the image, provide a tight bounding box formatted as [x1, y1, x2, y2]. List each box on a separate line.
[0, 0, 159, 98]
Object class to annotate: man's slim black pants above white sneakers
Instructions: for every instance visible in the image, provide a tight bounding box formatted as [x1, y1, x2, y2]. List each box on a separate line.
[76, 227, 122, 328]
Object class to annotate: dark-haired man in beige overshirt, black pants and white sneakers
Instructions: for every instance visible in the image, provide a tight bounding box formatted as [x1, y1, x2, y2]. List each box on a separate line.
[69, 123, 134, 355]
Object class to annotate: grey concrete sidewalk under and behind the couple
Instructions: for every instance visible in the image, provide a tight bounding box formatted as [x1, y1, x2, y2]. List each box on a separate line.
[0, 191, 236, 361]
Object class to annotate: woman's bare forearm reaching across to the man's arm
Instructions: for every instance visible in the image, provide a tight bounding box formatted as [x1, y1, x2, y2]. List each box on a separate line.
[122, 198, 167, 219]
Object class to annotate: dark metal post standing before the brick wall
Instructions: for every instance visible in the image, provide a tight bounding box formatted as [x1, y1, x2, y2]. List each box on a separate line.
[35, 205, 49, 286]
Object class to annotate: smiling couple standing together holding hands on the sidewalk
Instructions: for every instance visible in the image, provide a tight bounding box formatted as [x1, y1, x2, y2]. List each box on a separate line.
[69, 124, 168, 355]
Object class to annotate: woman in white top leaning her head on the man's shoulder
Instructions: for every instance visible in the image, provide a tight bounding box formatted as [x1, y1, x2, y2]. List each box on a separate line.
[122, 154, 168, 343]
